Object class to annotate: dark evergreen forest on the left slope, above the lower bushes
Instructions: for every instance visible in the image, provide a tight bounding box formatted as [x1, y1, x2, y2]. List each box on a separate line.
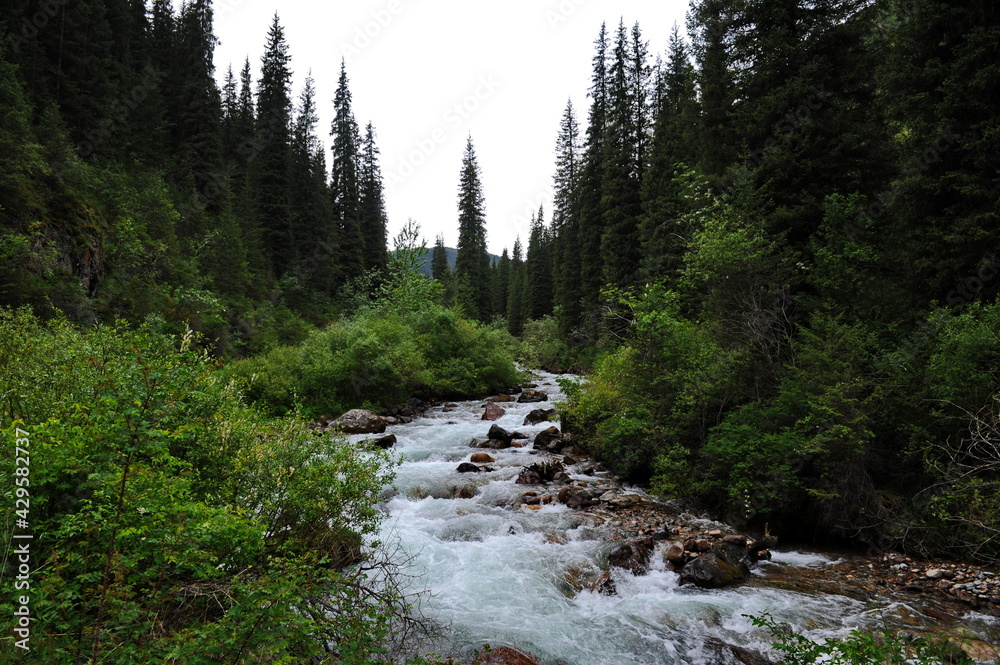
[0, 0, 388, 353]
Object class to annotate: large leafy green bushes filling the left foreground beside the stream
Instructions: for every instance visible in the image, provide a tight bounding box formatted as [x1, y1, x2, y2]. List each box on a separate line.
[0, 310, 422, 664]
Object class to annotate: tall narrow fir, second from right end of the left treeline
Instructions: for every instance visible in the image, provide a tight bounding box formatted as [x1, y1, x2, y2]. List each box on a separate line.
[330, 60, 365, 282]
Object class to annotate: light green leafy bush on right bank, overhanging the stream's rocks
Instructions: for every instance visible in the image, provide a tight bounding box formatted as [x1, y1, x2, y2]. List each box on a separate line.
[567, 286, 740, 482]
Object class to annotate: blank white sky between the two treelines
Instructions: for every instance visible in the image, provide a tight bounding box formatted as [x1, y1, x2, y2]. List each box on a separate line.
[214, 0, 687, 254]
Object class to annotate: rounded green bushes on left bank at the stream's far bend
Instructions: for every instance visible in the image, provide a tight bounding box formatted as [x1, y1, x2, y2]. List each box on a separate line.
[226, 227, 519, 416]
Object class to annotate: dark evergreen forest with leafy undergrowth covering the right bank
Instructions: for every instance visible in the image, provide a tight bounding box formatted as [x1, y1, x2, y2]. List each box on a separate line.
[504, 5, 1000, 559]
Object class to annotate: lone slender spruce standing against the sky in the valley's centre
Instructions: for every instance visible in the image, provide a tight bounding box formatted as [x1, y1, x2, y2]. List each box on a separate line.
[455, 136, 492, 321]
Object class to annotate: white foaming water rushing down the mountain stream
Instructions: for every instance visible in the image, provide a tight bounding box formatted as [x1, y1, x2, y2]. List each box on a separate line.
[362, 373, 992, 665]
